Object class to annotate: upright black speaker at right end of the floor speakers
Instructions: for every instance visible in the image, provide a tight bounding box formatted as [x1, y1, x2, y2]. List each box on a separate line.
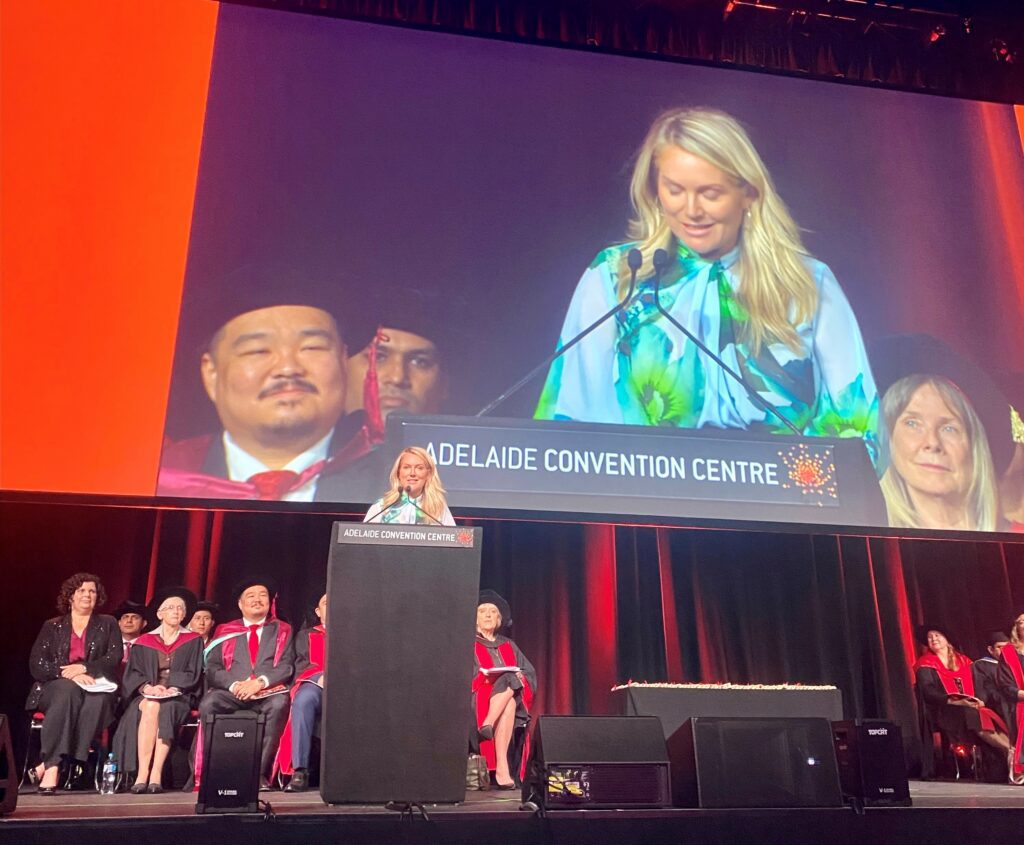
[833, 721, 910, 807]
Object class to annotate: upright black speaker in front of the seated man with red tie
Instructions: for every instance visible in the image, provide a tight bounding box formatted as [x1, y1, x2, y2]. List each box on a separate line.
[196, 710, 264, 813]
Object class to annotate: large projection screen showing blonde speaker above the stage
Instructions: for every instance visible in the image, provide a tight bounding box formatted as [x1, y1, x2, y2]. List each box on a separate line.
[157, 6, 1024, 532]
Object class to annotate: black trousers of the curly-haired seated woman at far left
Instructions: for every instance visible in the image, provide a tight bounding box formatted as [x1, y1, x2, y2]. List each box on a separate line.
[37, 678, 117, 768]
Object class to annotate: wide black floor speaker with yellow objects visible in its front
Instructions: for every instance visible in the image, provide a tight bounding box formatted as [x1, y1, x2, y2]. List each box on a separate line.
[522, 716, 671, 810]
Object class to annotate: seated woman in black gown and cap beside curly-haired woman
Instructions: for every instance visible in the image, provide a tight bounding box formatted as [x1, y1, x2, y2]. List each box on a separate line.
[114, 587, 203, 795]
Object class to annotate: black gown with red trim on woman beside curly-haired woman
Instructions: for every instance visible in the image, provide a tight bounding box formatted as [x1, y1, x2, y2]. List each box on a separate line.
[113, 631, 203, 771]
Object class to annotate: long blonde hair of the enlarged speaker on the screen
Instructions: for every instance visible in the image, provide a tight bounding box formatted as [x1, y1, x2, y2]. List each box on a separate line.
[620, 109, 818, 353]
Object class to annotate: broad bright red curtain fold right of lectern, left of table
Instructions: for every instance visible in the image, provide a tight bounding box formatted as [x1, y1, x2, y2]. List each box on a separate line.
[584, 525, 620, 713]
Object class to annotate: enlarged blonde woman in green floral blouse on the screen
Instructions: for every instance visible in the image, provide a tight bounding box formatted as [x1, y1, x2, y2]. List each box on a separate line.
[535, 109, 878, 459]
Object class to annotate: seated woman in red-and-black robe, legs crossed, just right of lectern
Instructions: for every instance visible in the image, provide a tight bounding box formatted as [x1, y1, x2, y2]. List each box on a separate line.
[472, 590, 537, 790]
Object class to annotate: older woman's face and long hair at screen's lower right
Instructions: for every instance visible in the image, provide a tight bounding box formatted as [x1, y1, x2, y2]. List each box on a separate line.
[881, 374, 999, 531]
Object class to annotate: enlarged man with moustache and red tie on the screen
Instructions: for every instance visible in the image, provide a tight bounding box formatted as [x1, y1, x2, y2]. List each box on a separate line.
[157, 294, 382, 502]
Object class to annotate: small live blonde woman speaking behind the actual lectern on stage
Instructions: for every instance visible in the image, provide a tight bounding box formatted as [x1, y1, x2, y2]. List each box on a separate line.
[362, 446, 455, 525]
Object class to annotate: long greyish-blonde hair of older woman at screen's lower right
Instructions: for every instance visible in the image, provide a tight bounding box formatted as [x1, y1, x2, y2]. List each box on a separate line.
[879, 373, 998, 531]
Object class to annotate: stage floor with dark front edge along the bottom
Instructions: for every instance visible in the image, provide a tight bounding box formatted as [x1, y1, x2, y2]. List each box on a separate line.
[0, 781, 1024, 845]
